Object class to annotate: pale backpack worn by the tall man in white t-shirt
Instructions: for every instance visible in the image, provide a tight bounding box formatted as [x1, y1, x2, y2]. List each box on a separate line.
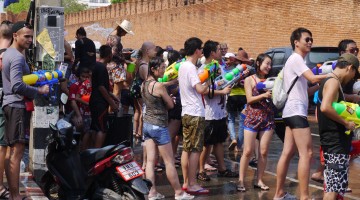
[272, 69, 299, 110]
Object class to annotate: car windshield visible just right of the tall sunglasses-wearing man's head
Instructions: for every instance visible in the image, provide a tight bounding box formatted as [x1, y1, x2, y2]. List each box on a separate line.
[309, 48, 339, 64]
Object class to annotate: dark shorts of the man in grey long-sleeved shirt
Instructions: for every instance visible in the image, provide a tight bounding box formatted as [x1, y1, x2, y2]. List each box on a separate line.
[3, 106, 31, 146]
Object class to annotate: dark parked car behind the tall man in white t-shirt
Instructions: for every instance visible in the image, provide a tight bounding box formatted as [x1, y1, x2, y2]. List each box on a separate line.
[265, 46, 339, 76]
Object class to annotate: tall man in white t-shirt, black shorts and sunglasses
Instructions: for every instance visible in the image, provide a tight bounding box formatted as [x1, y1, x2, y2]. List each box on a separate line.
[274, 28, 327, 200]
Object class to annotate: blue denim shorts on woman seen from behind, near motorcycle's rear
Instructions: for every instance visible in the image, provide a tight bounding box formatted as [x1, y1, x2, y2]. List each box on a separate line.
[143, 122, 171, 145]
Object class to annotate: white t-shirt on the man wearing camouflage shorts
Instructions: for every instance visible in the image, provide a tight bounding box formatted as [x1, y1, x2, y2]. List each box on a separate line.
[179, 61, 205, 117]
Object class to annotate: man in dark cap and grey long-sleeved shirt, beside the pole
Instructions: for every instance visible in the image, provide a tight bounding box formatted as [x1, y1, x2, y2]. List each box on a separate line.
[2, 21, 49, 200]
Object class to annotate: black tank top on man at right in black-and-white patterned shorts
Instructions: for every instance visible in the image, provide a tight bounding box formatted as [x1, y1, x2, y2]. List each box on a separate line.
[316, 77, 352, 154]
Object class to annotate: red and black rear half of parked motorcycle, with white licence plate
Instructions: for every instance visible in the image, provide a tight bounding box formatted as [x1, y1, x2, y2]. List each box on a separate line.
[80, 141, 152, 200]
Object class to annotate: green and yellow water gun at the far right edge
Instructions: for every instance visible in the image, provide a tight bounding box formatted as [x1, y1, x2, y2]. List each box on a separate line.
[332, 101, 360, 135]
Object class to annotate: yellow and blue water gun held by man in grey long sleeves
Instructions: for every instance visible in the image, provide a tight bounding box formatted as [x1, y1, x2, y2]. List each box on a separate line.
[23, 70, 63, 86]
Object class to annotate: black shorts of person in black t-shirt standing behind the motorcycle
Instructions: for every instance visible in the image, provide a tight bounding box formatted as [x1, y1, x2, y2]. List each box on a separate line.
[90, 103, 109, 133]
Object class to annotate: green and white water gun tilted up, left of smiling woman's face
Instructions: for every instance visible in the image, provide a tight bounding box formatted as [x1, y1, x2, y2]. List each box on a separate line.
[214, 64, 248, 90]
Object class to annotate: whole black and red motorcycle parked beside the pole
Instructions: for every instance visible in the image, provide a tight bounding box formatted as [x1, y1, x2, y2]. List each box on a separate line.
[41, 93, 152, 200]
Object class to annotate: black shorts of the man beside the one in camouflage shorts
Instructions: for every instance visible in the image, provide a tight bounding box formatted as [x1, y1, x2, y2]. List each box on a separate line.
[204, 118, 228, 146]
